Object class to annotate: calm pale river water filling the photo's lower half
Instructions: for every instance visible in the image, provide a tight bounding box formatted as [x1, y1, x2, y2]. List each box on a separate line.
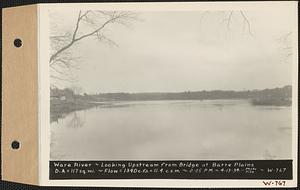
[50, 100, 292, 160]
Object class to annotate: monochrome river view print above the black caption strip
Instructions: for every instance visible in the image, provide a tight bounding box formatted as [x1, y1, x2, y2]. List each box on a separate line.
[48, 2, 297, 161]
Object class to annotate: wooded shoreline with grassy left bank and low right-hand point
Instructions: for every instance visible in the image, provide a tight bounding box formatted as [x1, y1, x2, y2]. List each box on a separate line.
[50, 86, 292, 122]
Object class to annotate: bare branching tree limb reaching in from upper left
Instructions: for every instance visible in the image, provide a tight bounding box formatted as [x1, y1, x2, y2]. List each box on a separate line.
[49, 10, 137, 85]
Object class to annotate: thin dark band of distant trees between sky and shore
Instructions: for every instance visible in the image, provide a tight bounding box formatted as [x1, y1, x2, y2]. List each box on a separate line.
[51, 85, 292, 104]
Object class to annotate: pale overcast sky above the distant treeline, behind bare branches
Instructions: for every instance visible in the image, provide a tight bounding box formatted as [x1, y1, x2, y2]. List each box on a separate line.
[50, 6, 294, 93]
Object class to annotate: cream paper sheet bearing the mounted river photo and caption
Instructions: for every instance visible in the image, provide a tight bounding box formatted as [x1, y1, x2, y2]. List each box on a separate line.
[39, 2, 298, 187]
